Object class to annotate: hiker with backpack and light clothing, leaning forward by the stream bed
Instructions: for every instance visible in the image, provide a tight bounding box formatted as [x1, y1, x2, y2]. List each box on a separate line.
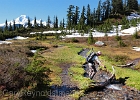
[87, 51, 105, 79]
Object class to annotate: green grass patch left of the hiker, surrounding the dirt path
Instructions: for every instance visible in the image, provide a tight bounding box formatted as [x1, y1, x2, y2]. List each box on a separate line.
[43, 43, 91, 99]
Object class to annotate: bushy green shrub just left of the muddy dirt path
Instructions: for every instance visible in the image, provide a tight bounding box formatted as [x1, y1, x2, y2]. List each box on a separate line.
[23, 52, 50, 100]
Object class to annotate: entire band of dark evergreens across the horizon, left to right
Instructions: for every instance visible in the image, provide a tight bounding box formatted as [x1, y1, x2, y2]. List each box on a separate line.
[0, 0, 140, 40]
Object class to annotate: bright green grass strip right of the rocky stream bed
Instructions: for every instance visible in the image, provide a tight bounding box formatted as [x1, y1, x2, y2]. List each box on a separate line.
[101, 53, 140, 90]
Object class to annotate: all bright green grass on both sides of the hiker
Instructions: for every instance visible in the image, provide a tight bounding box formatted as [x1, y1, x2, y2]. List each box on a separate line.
[41, 39, 140, 99]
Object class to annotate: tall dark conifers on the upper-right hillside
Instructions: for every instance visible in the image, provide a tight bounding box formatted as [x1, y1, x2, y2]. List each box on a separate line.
[67, 0, 139, 30]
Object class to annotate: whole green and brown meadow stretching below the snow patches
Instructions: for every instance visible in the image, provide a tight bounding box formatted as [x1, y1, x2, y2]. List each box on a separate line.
[1, 33, 140, 99]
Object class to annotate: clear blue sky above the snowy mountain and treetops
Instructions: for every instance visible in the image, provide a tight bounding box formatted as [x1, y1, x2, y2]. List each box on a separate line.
[0, 0, 140, 24]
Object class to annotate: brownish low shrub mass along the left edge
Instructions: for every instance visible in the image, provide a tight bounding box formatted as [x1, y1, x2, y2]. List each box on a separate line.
[0, 48, 29, 91]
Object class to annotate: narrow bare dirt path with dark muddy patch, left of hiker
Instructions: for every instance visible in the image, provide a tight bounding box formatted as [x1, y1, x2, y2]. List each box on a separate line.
[48, 63, 78, 100]
